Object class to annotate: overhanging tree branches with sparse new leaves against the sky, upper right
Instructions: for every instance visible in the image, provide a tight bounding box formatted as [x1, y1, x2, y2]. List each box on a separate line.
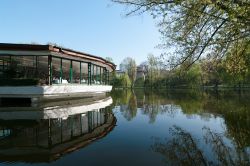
[112, 0, 250, 67]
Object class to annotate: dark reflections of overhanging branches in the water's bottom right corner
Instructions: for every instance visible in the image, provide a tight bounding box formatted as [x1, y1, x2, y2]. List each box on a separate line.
[151, 126, 250, 165]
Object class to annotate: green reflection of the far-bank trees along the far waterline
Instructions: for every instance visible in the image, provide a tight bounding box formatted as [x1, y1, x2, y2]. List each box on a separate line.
[112, 91, 250, 149]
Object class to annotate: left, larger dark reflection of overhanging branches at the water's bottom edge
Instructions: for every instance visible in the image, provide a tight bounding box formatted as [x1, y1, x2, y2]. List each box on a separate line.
[152, 126, 207, 165]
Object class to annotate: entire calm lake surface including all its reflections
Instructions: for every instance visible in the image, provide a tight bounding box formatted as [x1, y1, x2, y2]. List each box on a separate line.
[0, 90, 250, 166]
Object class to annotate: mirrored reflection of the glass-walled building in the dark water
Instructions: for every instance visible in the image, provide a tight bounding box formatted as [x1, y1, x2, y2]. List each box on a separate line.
[0, 97, 116, 163]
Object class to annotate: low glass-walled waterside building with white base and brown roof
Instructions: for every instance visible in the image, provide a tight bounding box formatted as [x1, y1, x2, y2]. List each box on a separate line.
[0, 43, 116, 101]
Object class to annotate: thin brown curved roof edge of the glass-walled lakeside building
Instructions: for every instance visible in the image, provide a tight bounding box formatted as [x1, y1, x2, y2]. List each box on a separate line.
[0, 43, 116, 69]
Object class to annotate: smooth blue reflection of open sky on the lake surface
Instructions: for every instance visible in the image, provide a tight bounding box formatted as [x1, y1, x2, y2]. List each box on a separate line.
[0, 94, 250, 166]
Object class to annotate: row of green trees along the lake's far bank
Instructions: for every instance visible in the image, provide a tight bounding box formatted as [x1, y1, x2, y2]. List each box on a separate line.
[112, 42, 250, 89]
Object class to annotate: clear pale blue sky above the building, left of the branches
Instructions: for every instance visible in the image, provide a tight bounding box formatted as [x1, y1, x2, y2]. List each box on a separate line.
[0, 0, 161, 67]
